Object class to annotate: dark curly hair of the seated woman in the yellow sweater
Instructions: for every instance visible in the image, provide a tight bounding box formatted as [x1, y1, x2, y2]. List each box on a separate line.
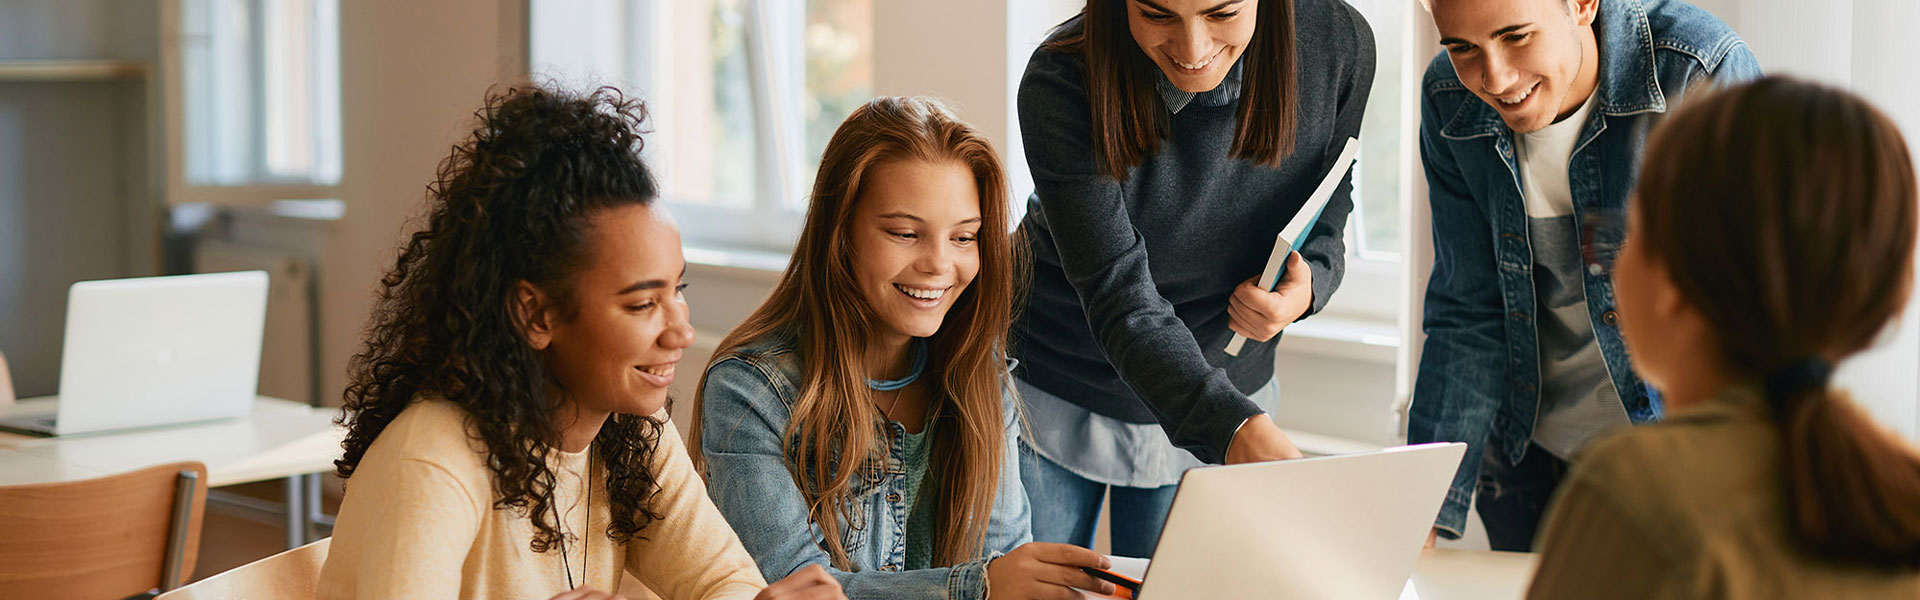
[334, 87, 662, 552]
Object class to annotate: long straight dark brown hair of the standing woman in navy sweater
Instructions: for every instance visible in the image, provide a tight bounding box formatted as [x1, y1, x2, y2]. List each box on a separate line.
[1044, 0, 1300, 179]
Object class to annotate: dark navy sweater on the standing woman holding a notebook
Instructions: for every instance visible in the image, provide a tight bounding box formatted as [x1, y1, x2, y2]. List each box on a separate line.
[1014, 0, 1375, 462]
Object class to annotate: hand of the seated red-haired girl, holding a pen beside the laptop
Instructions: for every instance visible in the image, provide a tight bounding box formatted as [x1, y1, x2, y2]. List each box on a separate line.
[987, 542, 1114, 600]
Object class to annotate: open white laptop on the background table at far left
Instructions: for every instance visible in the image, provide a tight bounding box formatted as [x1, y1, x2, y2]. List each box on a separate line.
[0, 271, 267, 435]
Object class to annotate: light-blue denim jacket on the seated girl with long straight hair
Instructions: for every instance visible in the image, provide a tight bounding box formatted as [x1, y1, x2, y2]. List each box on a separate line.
[699, 337, 1033, 600]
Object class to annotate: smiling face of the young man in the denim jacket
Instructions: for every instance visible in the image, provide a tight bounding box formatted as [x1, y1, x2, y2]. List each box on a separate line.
[1430, 0, 1599, 133]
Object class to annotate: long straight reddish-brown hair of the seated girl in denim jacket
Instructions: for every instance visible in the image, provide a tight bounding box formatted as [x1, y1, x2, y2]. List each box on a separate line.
[687, 96, 1025, 569]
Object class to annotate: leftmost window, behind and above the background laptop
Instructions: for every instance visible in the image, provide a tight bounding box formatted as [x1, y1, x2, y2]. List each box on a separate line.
[167, 0, 342, 194]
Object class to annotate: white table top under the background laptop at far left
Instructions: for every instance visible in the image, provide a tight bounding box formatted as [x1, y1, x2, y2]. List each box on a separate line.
[0, 396, 344, 487]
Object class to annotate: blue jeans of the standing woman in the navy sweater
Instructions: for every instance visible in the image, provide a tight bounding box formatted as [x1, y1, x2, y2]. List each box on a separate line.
[1020, 444, 1179, 558]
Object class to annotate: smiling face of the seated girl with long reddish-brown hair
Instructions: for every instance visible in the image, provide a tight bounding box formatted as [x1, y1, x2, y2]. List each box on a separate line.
[851, 160, 981, 342]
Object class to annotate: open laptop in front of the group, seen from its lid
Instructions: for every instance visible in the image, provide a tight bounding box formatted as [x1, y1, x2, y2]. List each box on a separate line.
[1116, 444, 1467, 600]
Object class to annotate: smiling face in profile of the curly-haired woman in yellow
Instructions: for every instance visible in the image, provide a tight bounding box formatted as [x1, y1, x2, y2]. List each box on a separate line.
[528, 204, 693, 415]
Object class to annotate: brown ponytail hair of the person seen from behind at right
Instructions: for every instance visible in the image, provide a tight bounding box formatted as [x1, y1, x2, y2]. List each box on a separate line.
[1634, 79, 1920, 569]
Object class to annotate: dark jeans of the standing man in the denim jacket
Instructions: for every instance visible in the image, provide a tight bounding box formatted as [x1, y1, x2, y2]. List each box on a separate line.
[1474, 444, 1567, 552]
